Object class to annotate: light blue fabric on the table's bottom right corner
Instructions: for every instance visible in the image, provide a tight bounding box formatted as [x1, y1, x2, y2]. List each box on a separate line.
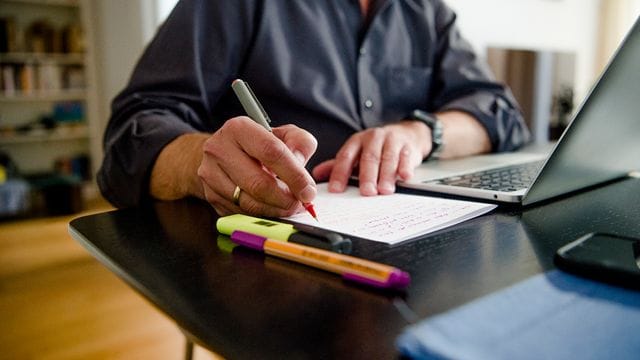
[396, 271, 640, 359]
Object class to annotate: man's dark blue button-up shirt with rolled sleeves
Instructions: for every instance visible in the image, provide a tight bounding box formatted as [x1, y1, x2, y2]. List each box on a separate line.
[98, 0, 528, 206]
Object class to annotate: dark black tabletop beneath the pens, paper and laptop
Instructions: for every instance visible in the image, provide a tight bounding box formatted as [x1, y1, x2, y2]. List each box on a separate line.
[70, 179, 640, 359]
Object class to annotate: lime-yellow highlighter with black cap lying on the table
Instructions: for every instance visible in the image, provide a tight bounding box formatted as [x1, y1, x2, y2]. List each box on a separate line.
[216, 214, 351, 254]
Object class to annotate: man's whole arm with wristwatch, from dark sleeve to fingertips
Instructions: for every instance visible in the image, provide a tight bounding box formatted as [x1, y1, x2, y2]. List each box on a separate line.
[313, 1, 528, 195]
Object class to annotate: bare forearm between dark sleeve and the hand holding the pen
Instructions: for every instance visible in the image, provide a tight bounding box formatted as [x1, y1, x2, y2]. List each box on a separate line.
[149, 133, 210, 200]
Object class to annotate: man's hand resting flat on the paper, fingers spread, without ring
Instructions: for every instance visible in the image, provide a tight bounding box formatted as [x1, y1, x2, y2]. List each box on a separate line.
[313, 121, 431, 196]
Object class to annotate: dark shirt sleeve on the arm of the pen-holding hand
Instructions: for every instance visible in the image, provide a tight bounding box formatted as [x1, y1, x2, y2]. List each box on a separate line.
[97, 0, 254, 207]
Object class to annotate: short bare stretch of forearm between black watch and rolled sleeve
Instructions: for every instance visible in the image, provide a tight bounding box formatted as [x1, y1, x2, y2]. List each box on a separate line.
[436, 111, 491, 159]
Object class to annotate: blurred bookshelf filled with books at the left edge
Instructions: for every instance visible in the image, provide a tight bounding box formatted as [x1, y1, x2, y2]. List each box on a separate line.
[0, 0, 100, 186]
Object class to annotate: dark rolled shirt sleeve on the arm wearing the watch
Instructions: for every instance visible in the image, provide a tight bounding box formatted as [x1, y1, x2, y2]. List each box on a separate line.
[431, 4, 530, 152]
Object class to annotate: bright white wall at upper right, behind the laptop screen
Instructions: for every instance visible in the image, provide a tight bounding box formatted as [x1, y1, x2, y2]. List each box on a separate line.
[445, 0, 600, 100]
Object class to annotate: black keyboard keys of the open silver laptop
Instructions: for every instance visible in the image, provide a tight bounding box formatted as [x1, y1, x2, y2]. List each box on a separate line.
[437, 160, 544, 192]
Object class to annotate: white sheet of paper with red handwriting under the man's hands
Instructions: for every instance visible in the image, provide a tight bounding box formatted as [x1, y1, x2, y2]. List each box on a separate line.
[284, 183, 496, 244]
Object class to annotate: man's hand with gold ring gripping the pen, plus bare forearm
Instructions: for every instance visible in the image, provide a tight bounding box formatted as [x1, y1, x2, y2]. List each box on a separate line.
[151, 116, 317, 217]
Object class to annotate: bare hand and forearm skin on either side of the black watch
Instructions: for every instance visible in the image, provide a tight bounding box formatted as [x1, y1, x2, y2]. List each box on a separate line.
[312, 111, 491, 195]
